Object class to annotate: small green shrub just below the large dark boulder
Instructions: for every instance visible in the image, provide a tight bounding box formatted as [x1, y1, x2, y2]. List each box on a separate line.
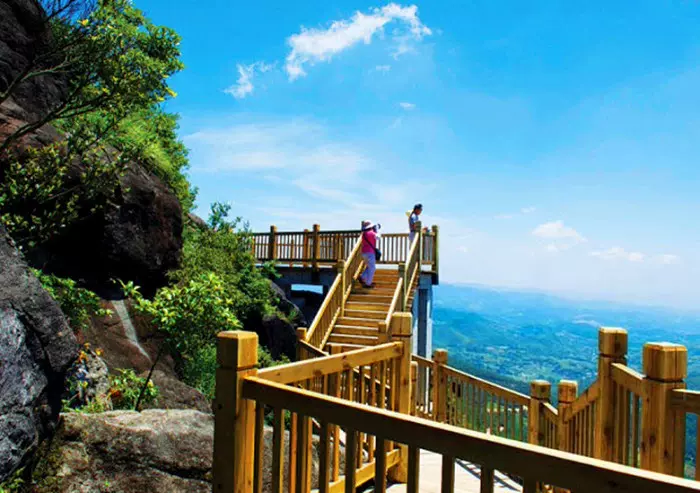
[32, 269, 112, 330]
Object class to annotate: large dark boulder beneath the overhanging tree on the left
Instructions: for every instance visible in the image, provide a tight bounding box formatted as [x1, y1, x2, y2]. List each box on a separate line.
[36, 163, 182, 295]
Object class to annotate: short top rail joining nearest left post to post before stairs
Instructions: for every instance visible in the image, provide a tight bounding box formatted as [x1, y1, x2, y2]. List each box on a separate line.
[258, 342, 403, 383]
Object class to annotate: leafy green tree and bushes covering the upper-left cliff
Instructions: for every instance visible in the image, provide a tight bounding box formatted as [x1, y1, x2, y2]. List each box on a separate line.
[0, 0, 189, 249]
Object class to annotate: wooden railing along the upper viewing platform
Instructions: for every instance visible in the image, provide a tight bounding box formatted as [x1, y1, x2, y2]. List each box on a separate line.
[250, 224, 439, 275]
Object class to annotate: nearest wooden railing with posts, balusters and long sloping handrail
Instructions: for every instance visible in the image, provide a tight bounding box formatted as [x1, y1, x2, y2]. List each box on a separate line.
[213, 320, 700, 493]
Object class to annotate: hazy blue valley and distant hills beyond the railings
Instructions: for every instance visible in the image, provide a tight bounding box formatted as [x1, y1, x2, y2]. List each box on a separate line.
[433, 284, 700, 393]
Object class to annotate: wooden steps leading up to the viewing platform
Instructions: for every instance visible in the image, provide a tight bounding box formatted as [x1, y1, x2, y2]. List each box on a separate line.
[326, 268, 417, 351]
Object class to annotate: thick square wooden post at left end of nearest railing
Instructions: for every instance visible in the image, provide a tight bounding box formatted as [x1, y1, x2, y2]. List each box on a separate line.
[212, 331, 258, 493]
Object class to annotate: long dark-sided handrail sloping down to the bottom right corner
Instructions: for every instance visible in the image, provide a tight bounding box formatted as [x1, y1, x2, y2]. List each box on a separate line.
[243, 377, 700, 493]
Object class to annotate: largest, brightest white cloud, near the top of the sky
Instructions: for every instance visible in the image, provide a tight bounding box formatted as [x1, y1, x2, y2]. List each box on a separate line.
[285, 3, 432, 80]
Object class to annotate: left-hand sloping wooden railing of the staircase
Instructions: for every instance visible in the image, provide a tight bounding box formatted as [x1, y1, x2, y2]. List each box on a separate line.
[304, 238, 363, 350]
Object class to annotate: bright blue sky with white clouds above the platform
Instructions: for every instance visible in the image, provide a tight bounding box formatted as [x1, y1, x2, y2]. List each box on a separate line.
[137, 0, 700, 308]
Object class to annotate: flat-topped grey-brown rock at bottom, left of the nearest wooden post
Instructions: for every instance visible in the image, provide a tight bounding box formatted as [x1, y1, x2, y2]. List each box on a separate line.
[32, 410, 334, 493]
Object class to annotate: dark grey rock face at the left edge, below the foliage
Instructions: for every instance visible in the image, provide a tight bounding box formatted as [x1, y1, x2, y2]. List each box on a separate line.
[0, 226, 78, 481]
